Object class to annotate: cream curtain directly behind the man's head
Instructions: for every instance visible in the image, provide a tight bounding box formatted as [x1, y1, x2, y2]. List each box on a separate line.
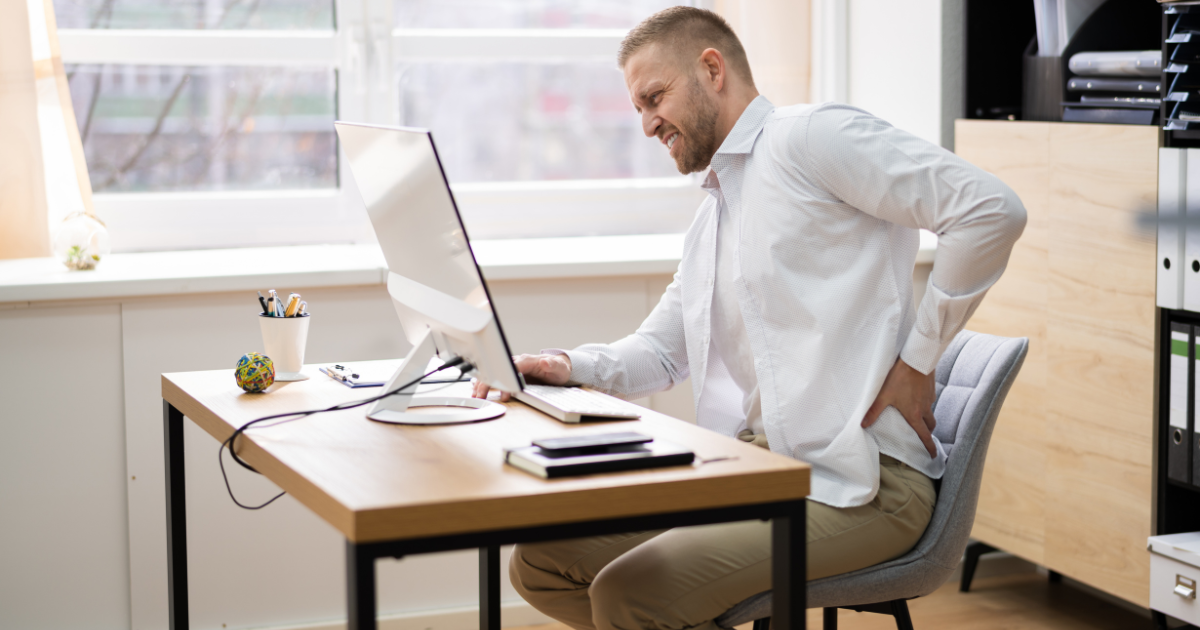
[714, 0, 812, 107]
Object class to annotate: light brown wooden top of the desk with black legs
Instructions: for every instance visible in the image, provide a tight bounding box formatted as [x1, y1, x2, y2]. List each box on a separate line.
[162, 361, 809, 542]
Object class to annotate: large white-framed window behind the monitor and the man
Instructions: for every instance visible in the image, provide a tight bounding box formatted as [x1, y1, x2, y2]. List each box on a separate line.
[55, 0, 700, 251]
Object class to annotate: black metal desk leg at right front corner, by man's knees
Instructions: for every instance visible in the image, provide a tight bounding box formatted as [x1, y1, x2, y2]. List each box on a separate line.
[770, 502, 808, 630]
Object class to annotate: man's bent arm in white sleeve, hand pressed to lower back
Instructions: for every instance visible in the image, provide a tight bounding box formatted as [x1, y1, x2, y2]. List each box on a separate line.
[798, 108, 1025, 455]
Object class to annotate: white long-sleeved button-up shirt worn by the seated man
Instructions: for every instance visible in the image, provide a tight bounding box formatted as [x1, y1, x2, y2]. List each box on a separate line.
[556, 96, 1025, 508]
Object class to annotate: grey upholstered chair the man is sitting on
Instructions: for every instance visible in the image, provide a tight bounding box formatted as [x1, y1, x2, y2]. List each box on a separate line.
[716, 330, 1030, 630]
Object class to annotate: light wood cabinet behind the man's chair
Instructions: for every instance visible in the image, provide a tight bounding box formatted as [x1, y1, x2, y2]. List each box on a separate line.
[955, 120, 1158, 606]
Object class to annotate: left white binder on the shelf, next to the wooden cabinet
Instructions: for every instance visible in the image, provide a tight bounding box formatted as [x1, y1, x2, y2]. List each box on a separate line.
[1156, 148, 1187, 308]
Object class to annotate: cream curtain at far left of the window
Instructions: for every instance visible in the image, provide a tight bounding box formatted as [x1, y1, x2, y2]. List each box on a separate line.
[0, 0, 92, 258]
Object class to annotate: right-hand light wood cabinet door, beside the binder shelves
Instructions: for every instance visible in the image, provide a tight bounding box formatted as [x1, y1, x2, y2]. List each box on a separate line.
[1044, 124, 1158, 606]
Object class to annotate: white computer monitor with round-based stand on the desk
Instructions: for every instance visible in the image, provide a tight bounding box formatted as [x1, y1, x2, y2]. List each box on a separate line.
[334, 121, 522, 424]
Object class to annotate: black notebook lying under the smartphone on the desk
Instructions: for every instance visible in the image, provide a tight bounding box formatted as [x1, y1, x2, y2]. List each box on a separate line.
[504, 440, 696, 479]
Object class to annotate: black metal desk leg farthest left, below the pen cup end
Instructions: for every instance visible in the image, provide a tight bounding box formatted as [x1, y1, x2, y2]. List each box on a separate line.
[162, 401, 187, 630]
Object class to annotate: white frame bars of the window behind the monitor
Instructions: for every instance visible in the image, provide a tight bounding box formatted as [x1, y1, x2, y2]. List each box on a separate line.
[59, 0, 703, 252]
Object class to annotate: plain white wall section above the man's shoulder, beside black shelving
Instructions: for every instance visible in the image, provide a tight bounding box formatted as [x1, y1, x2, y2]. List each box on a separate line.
[844, 0, 962, 149]
